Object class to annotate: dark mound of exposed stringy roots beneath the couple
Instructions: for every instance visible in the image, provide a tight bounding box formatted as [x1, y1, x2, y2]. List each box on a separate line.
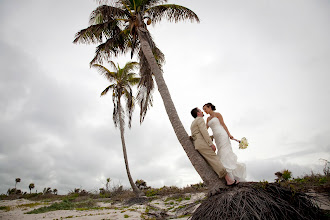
[190, 183, 326, 220]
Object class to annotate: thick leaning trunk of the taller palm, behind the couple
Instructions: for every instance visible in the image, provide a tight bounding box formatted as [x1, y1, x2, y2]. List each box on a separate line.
[138, 27, 225, 190]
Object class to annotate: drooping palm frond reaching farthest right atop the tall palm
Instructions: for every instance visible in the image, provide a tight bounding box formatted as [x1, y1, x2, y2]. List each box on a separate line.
[146, 4, 199, 24]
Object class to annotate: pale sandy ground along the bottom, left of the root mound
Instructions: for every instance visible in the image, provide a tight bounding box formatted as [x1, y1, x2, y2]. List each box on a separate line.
[0, 193, 205, 220]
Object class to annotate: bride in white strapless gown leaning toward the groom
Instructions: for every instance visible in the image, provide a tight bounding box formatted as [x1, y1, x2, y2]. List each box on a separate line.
[203, 103, 246, 181]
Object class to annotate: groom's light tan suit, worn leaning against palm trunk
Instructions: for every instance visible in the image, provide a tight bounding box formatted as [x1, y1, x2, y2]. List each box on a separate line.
[190, 117, 227, 178]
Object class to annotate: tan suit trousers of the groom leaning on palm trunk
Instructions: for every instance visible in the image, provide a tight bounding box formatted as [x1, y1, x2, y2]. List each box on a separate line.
[197, 147, 227, 178]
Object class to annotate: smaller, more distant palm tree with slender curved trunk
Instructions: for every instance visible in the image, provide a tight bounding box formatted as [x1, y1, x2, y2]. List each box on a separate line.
[92, 61, 143, 196]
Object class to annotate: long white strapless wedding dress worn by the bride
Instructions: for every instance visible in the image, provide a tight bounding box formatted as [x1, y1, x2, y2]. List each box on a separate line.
[208, 117, 246, 181]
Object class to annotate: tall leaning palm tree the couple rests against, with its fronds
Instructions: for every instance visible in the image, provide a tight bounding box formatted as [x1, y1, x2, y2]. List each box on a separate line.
[74, 0, 224, 187]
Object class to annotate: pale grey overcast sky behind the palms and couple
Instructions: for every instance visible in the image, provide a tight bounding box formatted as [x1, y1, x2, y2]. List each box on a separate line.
[0, 0, 330, 194]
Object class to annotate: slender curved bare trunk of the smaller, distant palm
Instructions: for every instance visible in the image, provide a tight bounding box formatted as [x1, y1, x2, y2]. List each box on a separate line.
[118, 98, 143, 196]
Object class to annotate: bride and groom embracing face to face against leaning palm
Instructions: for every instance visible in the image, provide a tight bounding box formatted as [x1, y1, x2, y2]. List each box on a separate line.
[190, 103, 246, 186]
